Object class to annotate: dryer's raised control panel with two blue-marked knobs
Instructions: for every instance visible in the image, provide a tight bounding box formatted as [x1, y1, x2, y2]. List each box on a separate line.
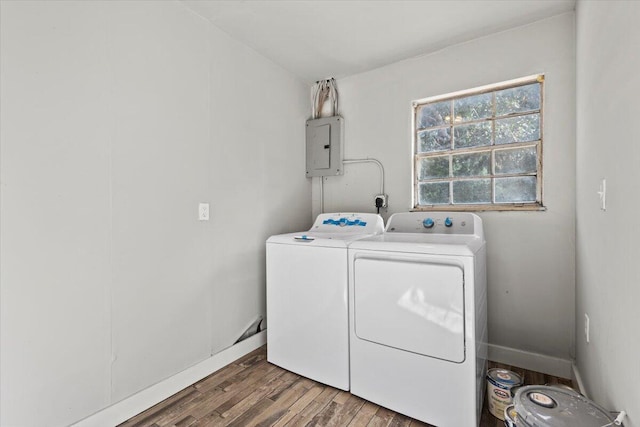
[385, 212, 482, 235]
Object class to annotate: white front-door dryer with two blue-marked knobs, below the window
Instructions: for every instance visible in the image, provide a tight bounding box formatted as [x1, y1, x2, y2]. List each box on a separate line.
[348, 212, 487, 427]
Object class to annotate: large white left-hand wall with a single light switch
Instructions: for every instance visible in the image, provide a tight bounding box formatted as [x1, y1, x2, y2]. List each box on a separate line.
[0, 1, 311, 427]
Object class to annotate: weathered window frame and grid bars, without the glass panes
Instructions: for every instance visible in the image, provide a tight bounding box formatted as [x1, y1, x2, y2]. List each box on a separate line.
[411, 74, 546, 212]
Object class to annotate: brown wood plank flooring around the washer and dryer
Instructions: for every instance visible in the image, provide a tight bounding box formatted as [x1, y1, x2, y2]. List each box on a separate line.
[119, 346, 571, 427]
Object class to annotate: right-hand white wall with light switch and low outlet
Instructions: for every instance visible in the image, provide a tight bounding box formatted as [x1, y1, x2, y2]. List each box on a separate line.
[576, 1, 640, 427]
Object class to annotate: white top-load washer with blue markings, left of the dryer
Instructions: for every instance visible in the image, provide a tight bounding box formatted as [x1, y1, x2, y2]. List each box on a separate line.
[267, 213, 384, 390]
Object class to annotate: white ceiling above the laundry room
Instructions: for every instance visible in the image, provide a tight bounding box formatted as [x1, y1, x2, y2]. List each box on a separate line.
[182, 0, 576, 83]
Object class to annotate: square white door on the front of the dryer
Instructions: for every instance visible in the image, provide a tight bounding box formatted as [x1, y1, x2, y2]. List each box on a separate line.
[353, 257, 465, 363]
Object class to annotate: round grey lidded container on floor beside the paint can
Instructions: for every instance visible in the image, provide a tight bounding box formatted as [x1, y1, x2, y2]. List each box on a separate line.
[514, 385, 613, 427]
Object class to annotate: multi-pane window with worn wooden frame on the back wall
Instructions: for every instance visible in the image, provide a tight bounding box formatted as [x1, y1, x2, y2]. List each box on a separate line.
[413, 76, 544, 210]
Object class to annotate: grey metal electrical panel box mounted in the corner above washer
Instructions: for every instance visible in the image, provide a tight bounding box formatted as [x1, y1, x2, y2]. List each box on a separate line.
[307, 116, 344, 177]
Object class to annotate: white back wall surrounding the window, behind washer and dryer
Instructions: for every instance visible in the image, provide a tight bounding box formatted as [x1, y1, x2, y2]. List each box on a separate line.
[314, 13, 575, 375]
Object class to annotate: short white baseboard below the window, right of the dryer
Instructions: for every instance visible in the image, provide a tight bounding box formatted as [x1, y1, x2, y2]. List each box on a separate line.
[489, 344, 573, 378]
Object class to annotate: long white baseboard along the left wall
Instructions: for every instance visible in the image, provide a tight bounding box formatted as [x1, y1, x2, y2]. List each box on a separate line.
[72, 330, 267, 427]
